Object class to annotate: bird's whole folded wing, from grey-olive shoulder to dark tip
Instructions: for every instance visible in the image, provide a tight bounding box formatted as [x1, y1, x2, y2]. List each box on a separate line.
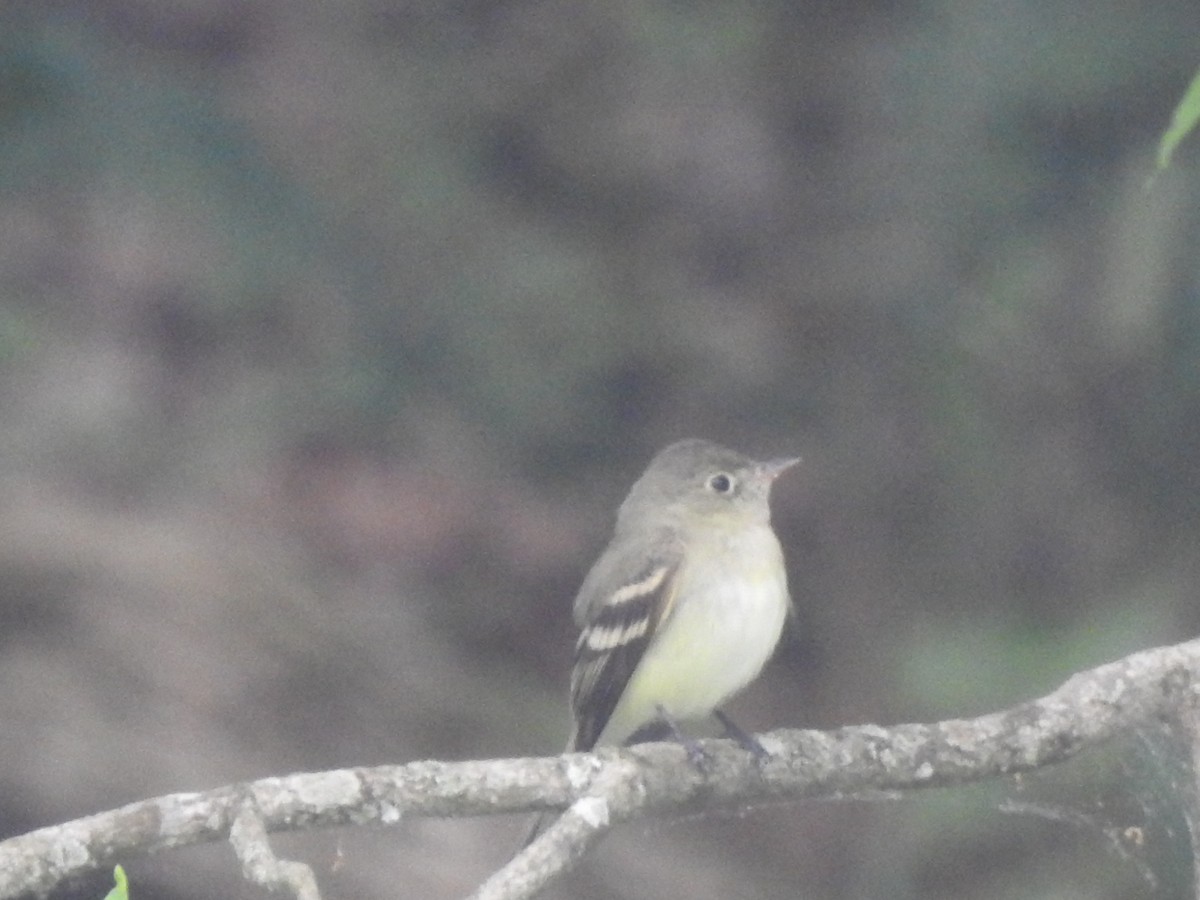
[570, 540, 683, 750]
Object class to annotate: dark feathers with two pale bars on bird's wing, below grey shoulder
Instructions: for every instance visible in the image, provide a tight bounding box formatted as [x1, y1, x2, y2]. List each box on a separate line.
[570, 557, 678, 750]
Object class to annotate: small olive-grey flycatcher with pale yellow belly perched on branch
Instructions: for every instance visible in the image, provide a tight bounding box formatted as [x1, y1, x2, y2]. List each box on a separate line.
[568, 439, 799, 751]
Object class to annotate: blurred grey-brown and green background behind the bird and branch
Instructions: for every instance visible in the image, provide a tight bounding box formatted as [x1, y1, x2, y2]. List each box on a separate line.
[0, 0, 1200, 900]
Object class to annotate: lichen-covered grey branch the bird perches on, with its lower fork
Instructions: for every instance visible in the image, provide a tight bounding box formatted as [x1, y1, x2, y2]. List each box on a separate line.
[0, 641, 1200, 900]
